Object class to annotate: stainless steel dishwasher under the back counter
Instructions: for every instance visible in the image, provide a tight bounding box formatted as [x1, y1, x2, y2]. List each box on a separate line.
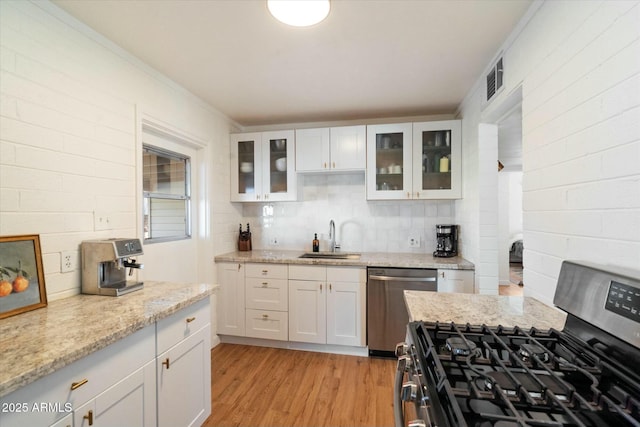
[367, 267, 438, 357]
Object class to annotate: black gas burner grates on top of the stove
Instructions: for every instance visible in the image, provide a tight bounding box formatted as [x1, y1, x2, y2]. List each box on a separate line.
[410, 322, 640, 427]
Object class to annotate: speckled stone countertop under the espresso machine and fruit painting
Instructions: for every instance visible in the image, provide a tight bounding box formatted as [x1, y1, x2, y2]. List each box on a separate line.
[0, 281, 218, 397]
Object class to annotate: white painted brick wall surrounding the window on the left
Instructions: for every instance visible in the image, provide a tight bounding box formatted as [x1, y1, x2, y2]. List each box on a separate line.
[0, 1, 235, 300]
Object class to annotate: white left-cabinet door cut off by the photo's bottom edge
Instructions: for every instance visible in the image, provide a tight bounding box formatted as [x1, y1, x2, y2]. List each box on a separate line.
[74, 361, 156, 427]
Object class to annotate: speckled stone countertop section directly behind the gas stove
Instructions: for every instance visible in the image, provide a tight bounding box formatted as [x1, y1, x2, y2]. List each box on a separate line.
[404, 291, 567, 330]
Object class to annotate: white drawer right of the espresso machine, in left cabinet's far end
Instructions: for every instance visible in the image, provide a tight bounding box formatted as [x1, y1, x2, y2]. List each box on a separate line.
[157, 298, 211, 354]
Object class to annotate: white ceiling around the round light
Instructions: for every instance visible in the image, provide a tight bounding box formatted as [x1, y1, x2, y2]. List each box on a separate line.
[54, 0, 531, 126]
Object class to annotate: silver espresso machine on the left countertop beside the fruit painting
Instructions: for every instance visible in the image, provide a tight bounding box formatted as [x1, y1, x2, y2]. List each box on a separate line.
[81, 239, 144, 296]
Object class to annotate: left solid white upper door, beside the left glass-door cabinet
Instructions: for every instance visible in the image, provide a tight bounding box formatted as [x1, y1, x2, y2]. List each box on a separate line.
[296, 128, 331, 172]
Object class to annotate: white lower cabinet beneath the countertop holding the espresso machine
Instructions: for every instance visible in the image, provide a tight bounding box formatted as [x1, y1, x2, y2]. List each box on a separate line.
[0, 298, 211, 427]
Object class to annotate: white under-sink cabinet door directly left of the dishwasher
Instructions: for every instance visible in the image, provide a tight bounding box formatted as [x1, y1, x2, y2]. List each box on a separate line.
[327, 281, 366, 347]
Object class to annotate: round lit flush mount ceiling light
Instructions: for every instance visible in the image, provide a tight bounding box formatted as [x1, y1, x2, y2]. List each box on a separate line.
[267, 0, 331, 27]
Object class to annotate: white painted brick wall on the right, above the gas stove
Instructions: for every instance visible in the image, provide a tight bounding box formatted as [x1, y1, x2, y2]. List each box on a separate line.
[461, 1, 640, 303]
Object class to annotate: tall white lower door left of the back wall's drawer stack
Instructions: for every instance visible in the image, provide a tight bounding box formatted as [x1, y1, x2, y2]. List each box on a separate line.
[216, 262, 245, 337]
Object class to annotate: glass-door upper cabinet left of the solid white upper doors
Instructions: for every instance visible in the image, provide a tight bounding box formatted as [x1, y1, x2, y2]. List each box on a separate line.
[231, 130, 297, 202]
